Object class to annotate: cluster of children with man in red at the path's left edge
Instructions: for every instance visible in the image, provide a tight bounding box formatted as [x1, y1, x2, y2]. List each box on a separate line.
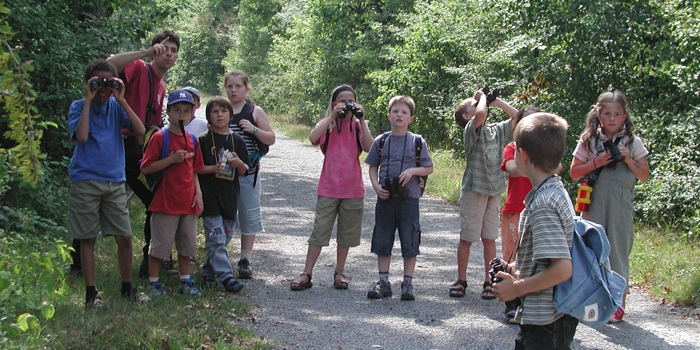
[68, 31, 275, 307]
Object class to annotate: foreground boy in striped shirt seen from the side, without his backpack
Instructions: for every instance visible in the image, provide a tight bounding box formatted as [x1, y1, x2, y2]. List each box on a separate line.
[493, 113, 578, 349]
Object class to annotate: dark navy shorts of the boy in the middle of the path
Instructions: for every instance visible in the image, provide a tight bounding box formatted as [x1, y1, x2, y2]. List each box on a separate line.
[371, 197, 421, 258]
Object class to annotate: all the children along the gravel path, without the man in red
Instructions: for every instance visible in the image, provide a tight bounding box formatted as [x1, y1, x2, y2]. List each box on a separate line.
[69, 28, 649, 349]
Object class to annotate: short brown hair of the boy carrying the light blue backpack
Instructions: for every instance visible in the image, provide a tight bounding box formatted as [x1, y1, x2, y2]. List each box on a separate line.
[513, 112, 569, 173]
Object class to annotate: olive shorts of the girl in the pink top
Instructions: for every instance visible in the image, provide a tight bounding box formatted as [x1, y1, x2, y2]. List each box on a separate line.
[309, 196, 365, 247]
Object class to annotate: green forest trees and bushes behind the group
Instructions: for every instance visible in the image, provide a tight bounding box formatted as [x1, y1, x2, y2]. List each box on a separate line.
[0, 0, 700, 348]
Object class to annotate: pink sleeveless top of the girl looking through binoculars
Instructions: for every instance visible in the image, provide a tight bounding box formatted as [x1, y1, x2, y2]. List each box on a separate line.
[315, 119, 365, 199]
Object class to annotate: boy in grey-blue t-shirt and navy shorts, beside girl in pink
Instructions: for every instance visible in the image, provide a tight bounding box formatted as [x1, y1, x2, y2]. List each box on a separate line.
[365, 96, 433, 300]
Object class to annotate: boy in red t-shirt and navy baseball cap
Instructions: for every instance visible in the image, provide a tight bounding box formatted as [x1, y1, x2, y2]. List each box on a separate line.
[141, 90, 204, 297]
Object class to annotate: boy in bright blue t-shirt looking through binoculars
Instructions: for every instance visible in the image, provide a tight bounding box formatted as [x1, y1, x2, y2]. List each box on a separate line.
[68, 59, 148, 307]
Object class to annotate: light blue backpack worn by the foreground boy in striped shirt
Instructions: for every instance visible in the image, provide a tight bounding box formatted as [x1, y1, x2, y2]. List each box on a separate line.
[543, 187, 627, 327]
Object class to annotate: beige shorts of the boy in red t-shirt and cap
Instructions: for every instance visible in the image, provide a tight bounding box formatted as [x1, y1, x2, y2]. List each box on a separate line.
[148, 212, 197, 259]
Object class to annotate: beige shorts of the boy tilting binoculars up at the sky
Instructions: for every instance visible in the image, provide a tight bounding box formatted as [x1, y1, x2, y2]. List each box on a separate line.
[459, 191, 501, 243]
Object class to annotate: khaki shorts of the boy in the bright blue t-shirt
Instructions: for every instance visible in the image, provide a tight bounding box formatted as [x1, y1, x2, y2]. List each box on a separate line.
[68, 180, 131, 239]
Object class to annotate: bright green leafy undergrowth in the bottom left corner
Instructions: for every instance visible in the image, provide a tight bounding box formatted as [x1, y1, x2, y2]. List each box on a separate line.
[0, 228, 70, 348]
